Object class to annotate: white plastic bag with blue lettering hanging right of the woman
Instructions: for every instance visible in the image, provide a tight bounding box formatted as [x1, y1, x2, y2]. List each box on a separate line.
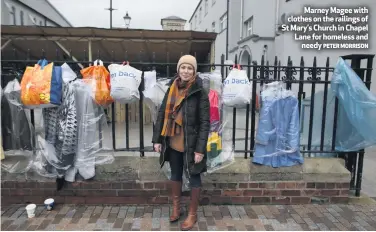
[222, 66, 252, 108]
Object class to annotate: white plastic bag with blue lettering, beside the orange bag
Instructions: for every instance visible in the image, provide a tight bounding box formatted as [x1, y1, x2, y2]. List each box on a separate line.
[108, 64, 142, 104]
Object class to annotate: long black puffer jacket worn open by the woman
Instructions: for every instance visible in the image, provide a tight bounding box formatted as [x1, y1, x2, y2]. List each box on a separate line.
[152, 77, 210, 175]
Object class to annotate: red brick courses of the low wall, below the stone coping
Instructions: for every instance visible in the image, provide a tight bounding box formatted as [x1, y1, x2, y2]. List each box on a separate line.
[1, 181, 349, 205]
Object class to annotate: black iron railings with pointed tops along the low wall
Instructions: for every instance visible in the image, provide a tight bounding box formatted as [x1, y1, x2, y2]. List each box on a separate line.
[1, 51, 373, 196]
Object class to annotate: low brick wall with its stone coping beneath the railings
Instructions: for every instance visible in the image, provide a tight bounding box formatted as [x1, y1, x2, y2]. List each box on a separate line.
[1, 157, 350, 205]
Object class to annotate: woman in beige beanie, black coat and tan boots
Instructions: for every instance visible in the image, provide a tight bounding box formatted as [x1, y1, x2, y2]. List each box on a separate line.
[152, 55, 210, 230]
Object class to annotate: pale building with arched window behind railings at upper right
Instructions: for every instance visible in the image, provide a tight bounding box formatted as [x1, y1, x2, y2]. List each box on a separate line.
[189, 0, 376, 66]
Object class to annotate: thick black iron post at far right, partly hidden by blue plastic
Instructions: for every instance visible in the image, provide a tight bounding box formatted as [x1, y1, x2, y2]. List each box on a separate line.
[342, 54, 375, 197]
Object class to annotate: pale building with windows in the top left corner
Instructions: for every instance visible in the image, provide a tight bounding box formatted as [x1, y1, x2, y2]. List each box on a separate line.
[1, 0, 72, 27]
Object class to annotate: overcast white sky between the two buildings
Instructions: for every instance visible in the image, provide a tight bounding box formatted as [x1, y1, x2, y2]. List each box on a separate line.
[49, 0, 199, 30]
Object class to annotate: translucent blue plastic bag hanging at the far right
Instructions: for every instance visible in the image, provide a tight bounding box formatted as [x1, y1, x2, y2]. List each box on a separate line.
[331, 58, 376, 151]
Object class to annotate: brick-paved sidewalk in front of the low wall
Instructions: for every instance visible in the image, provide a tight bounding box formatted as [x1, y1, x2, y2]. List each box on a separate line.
[1, 204, 376, 231]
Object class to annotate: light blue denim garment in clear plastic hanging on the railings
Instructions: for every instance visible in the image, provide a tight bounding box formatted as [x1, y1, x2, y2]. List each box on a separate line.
[253, 82, 303, 168]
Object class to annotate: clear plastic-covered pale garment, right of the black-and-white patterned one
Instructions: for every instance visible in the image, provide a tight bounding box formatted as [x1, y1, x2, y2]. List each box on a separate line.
[65, 80, 115, 182]
